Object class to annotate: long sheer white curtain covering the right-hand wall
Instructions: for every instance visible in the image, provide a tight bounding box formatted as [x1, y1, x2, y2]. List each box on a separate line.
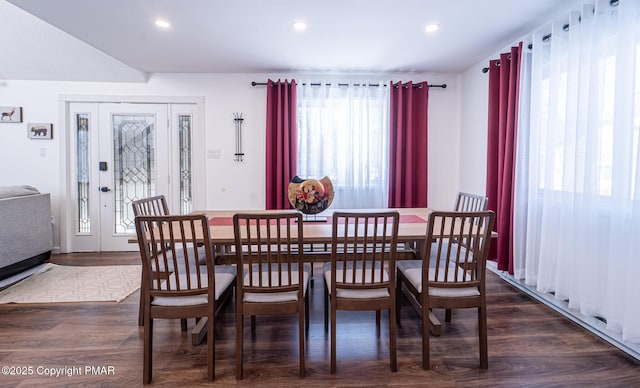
[515, 0, 640, 343]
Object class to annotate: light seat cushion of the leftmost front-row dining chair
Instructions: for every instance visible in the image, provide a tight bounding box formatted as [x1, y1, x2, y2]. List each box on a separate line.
[151, 265, 236, 306]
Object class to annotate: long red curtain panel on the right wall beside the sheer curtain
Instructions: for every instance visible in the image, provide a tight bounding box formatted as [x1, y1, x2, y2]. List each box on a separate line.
[486, 42, 522, 275]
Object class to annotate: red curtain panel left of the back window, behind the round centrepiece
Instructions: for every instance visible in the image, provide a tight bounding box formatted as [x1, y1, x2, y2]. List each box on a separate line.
[265, 80, 298, 209]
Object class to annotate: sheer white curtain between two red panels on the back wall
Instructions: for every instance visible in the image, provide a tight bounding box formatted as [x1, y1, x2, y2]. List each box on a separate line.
[297, 82, 389, 209]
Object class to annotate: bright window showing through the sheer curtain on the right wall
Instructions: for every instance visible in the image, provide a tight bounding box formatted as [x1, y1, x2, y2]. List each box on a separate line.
[538, 37, 640, 199]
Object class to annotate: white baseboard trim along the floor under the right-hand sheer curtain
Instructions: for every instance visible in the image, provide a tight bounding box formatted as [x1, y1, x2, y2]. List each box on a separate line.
[487, 262, 640, 361]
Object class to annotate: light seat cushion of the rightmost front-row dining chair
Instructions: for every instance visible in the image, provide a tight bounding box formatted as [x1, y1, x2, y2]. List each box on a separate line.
[396, 260, 480, 298]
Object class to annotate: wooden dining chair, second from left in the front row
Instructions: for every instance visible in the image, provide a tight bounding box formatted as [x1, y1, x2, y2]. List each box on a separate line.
[233, 212, 311, 380]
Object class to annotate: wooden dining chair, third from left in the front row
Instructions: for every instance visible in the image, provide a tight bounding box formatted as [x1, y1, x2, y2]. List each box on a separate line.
[324, 211, 400, 374]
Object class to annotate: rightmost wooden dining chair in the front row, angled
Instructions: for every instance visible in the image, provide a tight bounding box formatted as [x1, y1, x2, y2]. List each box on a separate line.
[396, 211, 495, 369]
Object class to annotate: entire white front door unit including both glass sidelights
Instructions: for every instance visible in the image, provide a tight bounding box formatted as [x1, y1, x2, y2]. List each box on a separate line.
[68, 103, 195, 252]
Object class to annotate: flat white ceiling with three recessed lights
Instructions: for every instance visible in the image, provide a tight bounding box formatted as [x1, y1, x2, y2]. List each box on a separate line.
[0, 0, 580, 79]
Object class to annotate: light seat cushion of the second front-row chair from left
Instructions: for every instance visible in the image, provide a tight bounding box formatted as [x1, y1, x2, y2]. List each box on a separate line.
[242, 264, 311, 303]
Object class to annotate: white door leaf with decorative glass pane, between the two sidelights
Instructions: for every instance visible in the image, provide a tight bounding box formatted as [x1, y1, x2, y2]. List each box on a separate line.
[98, 104, 170, 251]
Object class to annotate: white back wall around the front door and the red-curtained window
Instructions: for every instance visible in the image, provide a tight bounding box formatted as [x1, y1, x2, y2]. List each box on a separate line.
[0, 74, 461, 250]
